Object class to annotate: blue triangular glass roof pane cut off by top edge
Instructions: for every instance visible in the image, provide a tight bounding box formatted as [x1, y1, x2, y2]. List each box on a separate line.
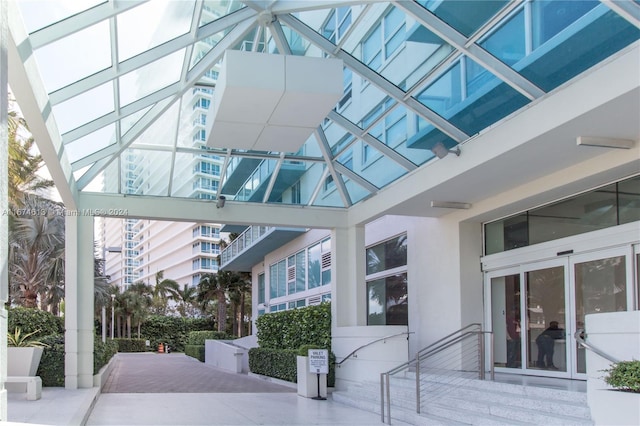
[418, 0, 508, 37]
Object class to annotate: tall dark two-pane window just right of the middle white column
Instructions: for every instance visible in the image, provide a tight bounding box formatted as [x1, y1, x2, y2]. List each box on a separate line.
[366, 235, 408, 325]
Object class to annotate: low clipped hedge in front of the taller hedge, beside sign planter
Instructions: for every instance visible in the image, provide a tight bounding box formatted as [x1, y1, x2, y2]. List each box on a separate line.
[249, 350, 298, 383]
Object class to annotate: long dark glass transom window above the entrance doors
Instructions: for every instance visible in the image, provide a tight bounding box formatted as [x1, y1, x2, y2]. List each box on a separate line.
[485, 176, 640, 254]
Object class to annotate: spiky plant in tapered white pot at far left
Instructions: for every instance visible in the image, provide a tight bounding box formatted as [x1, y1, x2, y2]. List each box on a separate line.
[7, 327, 48, 376]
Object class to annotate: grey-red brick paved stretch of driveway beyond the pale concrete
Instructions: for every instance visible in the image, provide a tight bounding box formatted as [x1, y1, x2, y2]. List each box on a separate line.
[102, 353, 295, 393]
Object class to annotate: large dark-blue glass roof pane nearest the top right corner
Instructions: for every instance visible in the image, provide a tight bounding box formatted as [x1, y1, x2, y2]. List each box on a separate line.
[513, 2, 640, 91]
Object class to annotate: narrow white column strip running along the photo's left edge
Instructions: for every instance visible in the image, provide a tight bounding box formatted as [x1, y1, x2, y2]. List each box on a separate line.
[0, 1, 9, 422]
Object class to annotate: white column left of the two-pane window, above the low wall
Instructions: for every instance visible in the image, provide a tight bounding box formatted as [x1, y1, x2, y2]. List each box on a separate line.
[331, 226, 367, 327]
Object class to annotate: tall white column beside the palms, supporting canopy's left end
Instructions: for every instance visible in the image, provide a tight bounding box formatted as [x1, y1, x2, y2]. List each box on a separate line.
[64, 215, 94, 389]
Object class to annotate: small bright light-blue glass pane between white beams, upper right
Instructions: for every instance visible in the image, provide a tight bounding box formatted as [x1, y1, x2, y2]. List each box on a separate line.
[480, 10, 527, 65]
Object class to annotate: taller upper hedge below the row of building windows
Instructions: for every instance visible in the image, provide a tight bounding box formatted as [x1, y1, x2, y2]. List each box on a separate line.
[256, 303, 331, 349]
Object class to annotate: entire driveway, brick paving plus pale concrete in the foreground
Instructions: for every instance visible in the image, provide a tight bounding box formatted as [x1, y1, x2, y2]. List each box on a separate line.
[86, 354, 390, 426]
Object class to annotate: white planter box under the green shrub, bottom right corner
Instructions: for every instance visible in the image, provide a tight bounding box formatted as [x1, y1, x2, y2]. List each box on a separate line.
[590, 389, 640, 426]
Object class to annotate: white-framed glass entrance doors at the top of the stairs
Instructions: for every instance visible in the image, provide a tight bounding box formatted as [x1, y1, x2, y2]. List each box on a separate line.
[486, 246, 640, 379]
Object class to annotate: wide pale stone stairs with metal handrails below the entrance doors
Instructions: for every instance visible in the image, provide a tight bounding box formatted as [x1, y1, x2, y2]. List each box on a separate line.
[333, 373, 593, 426]
